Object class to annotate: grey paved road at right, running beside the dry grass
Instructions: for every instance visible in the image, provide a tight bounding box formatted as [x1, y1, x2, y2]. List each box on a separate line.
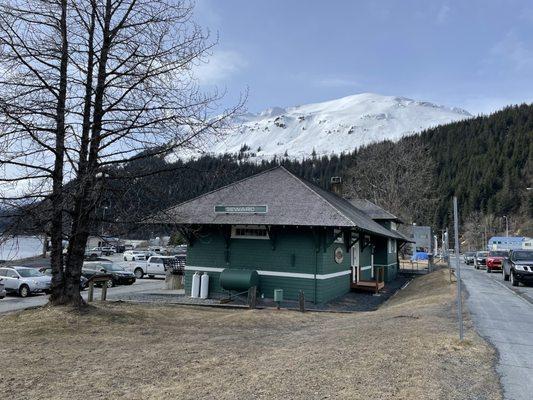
[461, 264, 533, 400]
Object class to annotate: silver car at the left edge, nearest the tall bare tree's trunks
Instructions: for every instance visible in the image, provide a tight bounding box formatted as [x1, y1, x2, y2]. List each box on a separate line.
[0, 267, 52, 297]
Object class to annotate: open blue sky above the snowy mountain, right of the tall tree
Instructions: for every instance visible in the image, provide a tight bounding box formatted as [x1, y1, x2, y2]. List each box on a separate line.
[195, 0, 533, 114]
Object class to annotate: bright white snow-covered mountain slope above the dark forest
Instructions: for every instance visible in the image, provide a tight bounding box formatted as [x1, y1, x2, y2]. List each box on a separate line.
[190, 93, 472, 159]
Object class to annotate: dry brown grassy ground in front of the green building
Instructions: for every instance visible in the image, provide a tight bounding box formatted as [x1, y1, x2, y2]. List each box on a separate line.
[0, 270, 502, 400]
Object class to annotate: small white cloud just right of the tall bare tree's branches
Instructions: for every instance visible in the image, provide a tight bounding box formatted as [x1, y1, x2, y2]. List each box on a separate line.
[193, 50, 248, 85]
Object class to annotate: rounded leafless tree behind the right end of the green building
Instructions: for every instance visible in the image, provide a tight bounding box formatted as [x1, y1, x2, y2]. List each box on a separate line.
[346, 138, 436, 223]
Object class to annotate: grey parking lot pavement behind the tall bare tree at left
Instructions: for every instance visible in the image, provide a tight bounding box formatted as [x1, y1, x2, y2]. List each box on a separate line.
[0, 279, 165, 314]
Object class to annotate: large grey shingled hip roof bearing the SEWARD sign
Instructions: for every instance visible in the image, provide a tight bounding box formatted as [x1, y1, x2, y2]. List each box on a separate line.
[149, 166, 405, 240]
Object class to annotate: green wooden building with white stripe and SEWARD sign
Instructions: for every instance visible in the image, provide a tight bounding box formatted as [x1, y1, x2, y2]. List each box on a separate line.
[151, 167, 408, 303]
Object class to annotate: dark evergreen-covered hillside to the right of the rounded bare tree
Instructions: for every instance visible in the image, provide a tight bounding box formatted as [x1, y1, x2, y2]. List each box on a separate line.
[420, 105, 533, 229]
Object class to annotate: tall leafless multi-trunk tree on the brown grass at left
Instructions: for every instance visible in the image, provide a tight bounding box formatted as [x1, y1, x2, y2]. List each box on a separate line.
[0, 0, 242, 306]
